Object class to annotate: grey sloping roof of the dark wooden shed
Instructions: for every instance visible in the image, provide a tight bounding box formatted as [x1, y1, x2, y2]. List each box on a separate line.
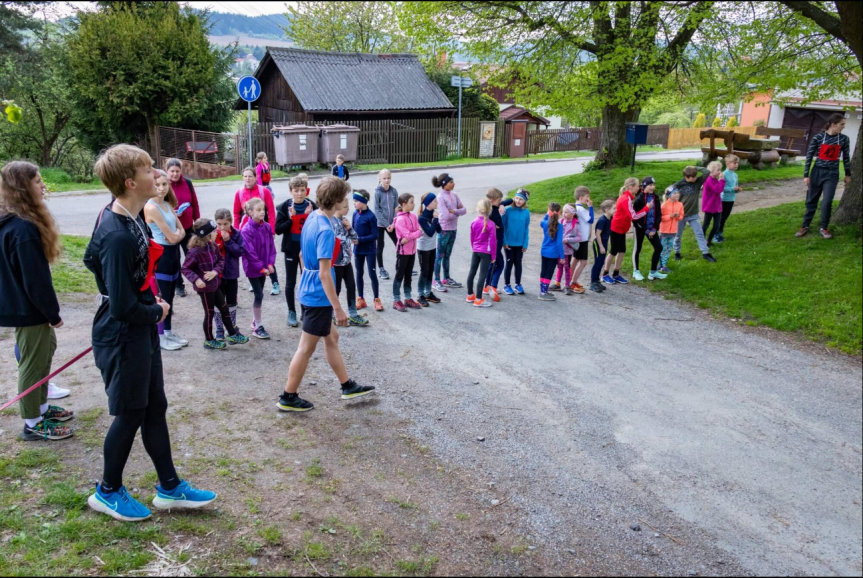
[264, 47, 453, 112]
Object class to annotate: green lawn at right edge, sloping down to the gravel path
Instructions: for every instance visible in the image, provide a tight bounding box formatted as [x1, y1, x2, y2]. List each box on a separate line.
[624, 203, 863, 355]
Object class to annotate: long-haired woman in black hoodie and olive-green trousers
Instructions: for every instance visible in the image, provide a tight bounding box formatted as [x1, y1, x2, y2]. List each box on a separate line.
[0, 161, 73, 441]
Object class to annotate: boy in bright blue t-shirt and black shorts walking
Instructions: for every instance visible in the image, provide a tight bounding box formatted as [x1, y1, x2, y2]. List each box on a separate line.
[277, 177, 375, 411]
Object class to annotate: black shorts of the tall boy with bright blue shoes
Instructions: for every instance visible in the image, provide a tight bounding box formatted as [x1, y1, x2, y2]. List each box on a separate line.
[93, 325, 168, 416]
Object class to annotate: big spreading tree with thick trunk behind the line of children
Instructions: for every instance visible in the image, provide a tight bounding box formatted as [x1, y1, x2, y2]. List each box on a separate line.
[400, 1, 712, 166]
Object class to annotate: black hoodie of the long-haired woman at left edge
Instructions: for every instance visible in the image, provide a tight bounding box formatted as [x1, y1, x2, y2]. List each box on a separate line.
[0, 214, 60, 327]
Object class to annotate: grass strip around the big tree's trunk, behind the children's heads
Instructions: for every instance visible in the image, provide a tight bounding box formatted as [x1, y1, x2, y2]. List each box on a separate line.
[510, 161, 803, 213]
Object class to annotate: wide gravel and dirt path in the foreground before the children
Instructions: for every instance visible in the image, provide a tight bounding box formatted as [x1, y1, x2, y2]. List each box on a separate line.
[0, 178, 863, 575]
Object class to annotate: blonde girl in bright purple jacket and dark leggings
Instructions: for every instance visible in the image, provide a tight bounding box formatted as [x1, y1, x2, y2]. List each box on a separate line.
[242, 197, 276, 339]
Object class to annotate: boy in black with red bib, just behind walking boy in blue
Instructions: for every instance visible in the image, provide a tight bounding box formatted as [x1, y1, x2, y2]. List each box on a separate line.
[276, 177, 318, 327]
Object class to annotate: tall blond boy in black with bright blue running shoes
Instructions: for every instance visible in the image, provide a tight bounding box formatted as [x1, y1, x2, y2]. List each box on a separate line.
[84, 145, 215, 521]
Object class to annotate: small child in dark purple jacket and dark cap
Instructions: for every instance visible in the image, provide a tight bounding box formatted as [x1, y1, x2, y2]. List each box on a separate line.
[183, 219, 249, 349]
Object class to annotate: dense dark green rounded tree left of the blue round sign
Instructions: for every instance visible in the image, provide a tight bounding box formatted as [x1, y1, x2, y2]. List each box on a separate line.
[67, 2, 236, 150]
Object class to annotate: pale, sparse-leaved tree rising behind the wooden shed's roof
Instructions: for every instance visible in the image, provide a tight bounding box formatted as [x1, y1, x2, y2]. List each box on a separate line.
[284, 2, 416, 53]
